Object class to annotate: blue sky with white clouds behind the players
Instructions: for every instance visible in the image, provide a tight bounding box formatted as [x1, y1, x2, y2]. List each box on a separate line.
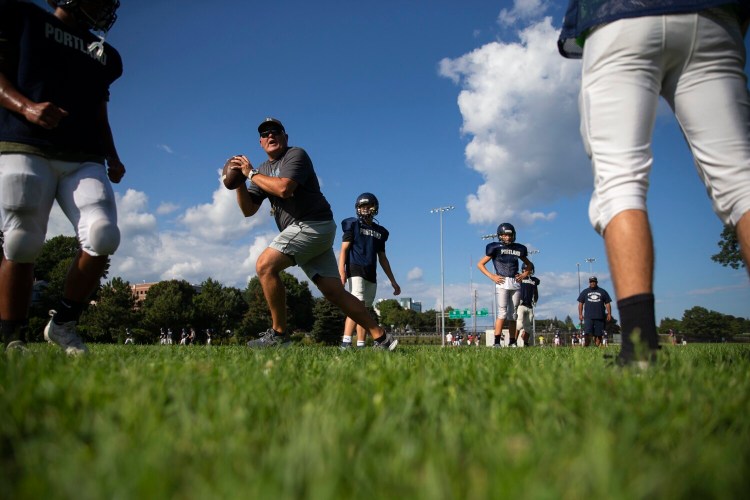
[38, 0, 750, 324]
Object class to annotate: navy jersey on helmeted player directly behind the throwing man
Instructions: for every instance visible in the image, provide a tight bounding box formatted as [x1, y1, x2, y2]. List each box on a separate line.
[341, 217, 388, 283]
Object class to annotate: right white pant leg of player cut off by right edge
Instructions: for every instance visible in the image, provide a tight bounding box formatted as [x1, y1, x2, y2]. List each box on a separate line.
[663, 9, 750, 226]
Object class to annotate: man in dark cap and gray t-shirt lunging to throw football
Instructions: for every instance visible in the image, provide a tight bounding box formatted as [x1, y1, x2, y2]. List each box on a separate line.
[231, 118, 398, 351]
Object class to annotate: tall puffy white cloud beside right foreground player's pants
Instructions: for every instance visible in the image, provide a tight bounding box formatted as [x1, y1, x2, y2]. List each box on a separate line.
[440, 16, 591, 224]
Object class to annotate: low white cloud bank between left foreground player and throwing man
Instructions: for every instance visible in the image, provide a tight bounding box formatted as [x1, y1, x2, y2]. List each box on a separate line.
[47, 186, 276, 288]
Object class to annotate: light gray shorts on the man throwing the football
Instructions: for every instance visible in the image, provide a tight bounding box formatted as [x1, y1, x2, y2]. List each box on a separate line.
[269, 220, 340, 281]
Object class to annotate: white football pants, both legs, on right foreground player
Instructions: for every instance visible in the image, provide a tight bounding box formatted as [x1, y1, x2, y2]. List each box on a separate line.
[579, 9, 750, 233]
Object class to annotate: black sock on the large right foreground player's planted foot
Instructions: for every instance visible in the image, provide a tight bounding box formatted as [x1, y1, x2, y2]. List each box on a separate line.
[617, 293, 659, 357]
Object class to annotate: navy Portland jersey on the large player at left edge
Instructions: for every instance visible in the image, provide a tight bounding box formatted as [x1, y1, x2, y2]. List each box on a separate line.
[0, 0, 122, 158]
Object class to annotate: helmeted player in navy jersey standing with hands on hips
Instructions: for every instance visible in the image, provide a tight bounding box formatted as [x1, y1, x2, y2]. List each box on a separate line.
[477, 222, 534, 347]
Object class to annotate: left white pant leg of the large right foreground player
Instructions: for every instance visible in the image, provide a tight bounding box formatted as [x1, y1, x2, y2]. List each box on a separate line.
[579, 17, 663, 233]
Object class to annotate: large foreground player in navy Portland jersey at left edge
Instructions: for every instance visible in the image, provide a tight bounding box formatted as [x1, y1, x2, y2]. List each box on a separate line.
[0, 0, 125, 355]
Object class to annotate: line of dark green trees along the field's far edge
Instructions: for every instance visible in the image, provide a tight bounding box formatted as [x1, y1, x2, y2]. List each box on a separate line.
[29, 236, 750, 345]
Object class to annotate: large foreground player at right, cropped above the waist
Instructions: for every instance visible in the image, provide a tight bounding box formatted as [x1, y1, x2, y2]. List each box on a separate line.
[558, 0, 750, 366]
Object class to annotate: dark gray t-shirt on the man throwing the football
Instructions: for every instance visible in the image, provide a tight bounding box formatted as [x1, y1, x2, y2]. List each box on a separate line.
[247, 147, 333, 231]
